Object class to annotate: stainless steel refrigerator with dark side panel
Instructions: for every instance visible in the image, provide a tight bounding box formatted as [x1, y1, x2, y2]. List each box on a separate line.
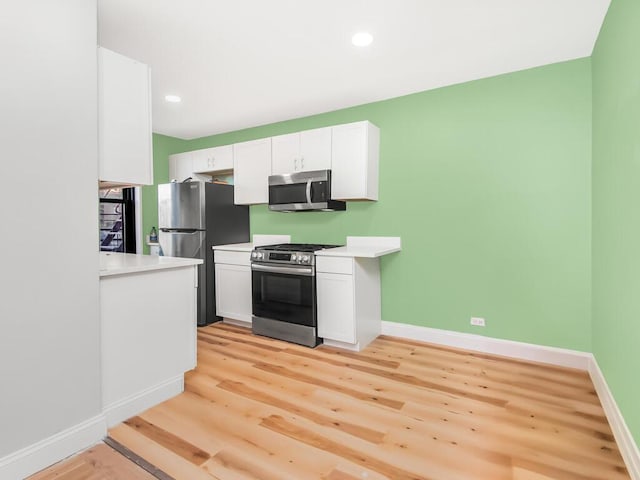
[158, 182, 249, 326]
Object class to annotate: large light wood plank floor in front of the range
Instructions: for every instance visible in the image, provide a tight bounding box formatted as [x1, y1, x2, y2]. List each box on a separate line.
[37, 324, 629, 480]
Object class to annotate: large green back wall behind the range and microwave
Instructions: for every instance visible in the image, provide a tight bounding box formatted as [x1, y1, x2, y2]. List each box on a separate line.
[178, 59, 591, 351]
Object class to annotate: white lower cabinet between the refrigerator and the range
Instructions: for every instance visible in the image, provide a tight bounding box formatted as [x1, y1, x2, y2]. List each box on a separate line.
[214, 250, 251, 323]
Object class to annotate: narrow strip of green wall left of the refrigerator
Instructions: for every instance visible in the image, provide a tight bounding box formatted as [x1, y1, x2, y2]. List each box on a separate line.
[142, 133, 190, 254]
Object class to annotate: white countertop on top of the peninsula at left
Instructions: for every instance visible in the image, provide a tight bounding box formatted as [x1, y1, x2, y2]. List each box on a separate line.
[100, 252, 203, 277]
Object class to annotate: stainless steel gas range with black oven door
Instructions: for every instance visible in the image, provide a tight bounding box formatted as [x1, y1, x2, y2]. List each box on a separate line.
[251, 243, 339, 347]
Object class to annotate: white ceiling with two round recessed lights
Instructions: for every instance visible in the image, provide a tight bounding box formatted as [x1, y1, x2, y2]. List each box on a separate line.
[98, 0, 610, 139]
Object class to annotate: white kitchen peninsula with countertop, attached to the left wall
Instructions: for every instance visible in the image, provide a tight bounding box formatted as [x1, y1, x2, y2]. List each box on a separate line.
[100, 252, 202, 427]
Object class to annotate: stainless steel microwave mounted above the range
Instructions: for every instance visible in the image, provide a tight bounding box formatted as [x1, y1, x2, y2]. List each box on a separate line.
[269, 170, 347, 212]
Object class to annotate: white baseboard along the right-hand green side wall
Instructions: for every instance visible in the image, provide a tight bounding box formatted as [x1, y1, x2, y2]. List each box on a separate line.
[589, 357, 640, 480]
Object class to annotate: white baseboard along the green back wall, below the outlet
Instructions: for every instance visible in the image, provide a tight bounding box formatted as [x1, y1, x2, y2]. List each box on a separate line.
[382, 321, 593, 370]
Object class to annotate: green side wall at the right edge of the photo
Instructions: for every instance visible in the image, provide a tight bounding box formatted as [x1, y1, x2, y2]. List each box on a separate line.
[592, 0, 640, 443]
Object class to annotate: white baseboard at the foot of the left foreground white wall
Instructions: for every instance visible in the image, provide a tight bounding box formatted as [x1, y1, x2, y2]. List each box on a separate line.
[0, 415, 107, 478]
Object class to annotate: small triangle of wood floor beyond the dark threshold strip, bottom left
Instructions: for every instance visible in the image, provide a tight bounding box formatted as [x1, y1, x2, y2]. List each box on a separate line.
[29, 443, 156, 480]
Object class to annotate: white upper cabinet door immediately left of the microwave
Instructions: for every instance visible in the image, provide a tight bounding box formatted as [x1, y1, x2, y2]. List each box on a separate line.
[233, 138, 271, 205]
